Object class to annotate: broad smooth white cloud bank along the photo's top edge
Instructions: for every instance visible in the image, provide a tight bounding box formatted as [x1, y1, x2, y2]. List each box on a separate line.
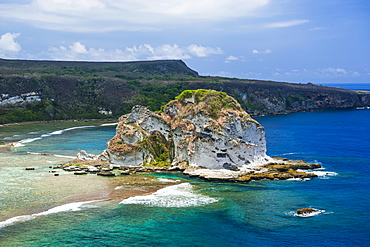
[0, 0, 271, 32]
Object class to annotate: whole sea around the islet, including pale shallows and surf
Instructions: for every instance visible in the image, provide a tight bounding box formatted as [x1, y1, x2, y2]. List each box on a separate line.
[0, 104, 370, 247]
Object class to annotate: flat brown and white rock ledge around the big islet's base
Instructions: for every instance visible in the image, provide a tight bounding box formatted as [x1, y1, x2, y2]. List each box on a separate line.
[54, 157, 322, 183]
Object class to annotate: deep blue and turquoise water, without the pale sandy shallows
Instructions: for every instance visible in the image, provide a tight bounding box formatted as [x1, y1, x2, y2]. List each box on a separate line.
[0, 110, 370, 246]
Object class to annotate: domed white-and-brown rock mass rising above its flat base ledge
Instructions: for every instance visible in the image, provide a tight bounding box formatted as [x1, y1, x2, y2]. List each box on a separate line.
[107, 90, 271, 170]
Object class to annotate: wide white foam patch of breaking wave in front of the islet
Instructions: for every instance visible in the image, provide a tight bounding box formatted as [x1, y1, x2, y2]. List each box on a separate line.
[120, 183, 218, 208]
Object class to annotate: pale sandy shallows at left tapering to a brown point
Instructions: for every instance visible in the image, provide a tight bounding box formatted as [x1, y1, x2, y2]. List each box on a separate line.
[0, 153, 174, 222]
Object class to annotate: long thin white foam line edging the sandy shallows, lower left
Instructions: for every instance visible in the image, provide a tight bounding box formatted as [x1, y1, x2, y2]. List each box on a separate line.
[0, 200, 97, 228]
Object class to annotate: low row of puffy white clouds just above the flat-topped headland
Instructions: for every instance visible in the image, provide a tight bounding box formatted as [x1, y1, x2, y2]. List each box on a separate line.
[48, 42, 223, 61]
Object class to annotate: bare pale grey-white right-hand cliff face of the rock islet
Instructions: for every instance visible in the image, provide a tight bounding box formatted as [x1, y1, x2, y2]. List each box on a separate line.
[169, 108, 270, 170]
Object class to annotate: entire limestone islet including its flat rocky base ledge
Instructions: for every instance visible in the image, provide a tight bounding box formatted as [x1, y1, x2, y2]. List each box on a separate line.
[63, 89, 321, 182]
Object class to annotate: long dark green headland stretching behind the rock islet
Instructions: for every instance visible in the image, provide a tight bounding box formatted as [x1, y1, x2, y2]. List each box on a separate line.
[0, 59, 369, 124]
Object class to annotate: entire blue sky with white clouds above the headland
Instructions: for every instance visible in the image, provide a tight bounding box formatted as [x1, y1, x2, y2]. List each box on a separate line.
[0, 0, 370, 84]
